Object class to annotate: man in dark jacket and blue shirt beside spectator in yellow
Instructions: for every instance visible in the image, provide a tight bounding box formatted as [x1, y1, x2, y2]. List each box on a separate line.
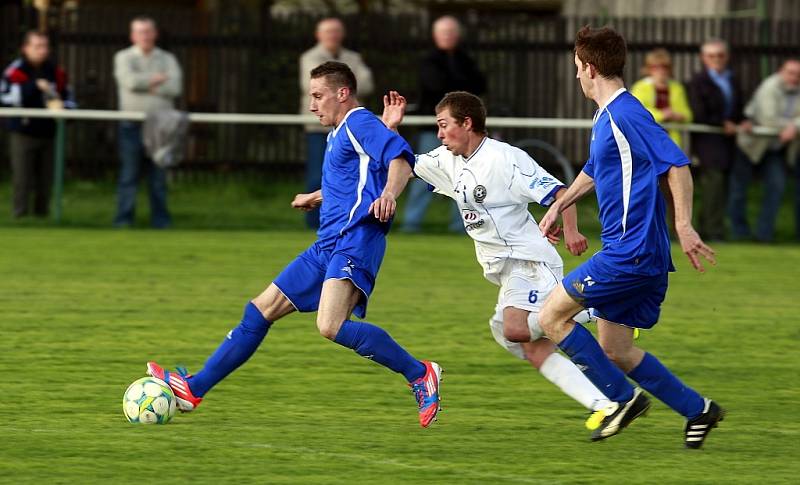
[689, 39, 744, 241]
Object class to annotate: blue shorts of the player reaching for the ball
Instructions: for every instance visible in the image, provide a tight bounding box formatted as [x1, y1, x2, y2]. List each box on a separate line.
[273, 225, 386, 318]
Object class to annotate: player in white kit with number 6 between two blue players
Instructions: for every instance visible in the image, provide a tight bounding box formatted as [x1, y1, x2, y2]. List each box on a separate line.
[383, 91, 608, 426]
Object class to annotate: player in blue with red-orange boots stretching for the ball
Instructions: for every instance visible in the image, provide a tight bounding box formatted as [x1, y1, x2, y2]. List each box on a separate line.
[147, 62, 441, 427]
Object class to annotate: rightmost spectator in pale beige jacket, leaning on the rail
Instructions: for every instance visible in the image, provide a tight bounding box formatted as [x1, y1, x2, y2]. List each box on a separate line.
[730, 59, 800, 242]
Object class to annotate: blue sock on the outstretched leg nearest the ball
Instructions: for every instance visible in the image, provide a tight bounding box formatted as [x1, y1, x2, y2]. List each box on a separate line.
[186, 302, 272, 397]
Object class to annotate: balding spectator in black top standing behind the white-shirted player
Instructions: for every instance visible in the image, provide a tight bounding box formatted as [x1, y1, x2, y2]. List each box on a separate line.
[401, 15, 486, 232]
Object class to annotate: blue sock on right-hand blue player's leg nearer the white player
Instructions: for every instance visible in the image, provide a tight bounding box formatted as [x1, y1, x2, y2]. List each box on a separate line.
[558, 324, 633, 402]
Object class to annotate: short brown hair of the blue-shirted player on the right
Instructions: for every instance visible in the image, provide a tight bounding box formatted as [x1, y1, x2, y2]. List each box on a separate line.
[575, 25, 628, 79]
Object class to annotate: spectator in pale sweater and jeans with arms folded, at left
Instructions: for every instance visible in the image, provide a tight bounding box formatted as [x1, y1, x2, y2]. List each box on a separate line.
[114, 17, 183, 229]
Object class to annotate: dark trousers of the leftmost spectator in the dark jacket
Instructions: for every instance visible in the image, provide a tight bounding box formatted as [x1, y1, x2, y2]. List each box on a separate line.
[9, 132, 53, 217]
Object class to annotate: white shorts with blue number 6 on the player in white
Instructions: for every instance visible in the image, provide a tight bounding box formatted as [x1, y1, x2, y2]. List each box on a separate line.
[489, 259, 594, 359]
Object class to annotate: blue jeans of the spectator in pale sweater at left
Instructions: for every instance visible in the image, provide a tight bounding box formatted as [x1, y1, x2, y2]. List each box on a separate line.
[114, 121, 172, 229]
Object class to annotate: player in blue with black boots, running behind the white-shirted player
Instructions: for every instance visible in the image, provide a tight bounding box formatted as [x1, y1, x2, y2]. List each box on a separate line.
[539, 27, 724, 448]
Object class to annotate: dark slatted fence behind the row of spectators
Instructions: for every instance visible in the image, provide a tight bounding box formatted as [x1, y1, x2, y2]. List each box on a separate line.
[0, 6, 800, 178]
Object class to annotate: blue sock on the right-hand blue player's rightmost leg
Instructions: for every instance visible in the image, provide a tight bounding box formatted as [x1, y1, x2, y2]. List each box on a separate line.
[628, 353, 705, 419]
